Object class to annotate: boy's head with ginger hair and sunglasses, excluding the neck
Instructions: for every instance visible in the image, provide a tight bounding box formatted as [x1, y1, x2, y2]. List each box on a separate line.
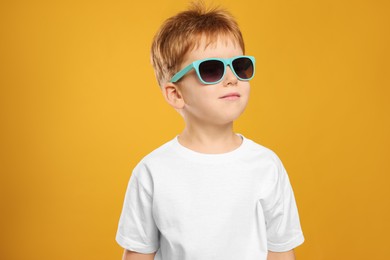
[151, 3, 254, 127]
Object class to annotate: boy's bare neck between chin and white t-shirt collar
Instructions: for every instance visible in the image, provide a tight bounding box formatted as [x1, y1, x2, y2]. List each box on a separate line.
[178, 123, 242, 154]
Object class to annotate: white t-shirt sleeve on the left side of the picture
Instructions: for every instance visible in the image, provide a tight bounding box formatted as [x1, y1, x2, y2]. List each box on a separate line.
[116, 164, 160, 254]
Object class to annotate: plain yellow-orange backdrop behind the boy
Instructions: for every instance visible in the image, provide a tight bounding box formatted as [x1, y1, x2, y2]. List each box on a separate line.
[0, 0, 390, 260]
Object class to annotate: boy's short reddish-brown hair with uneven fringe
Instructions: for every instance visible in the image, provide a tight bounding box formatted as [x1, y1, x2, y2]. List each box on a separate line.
[151, 1, 245, 87]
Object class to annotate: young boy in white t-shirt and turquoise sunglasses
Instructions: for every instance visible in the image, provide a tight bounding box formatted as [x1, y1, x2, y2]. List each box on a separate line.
[116, 2, 304, 260]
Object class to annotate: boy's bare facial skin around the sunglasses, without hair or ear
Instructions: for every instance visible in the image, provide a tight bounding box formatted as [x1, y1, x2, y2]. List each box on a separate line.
[177, 37, 250, 125]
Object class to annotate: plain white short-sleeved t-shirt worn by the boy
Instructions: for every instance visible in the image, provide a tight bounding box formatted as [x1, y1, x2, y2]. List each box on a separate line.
[116, 134, 304, 260]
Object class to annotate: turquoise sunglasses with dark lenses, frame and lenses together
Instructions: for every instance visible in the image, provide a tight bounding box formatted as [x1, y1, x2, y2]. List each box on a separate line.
[171, 56, 255, 85]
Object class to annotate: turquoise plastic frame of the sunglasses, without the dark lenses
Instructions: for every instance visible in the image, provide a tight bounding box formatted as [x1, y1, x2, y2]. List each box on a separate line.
[170, 55, 255, 85]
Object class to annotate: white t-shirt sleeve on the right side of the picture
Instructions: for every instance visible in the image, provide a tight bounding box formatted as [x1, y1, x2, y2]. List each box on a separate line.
[263, 155, 304, 252]
